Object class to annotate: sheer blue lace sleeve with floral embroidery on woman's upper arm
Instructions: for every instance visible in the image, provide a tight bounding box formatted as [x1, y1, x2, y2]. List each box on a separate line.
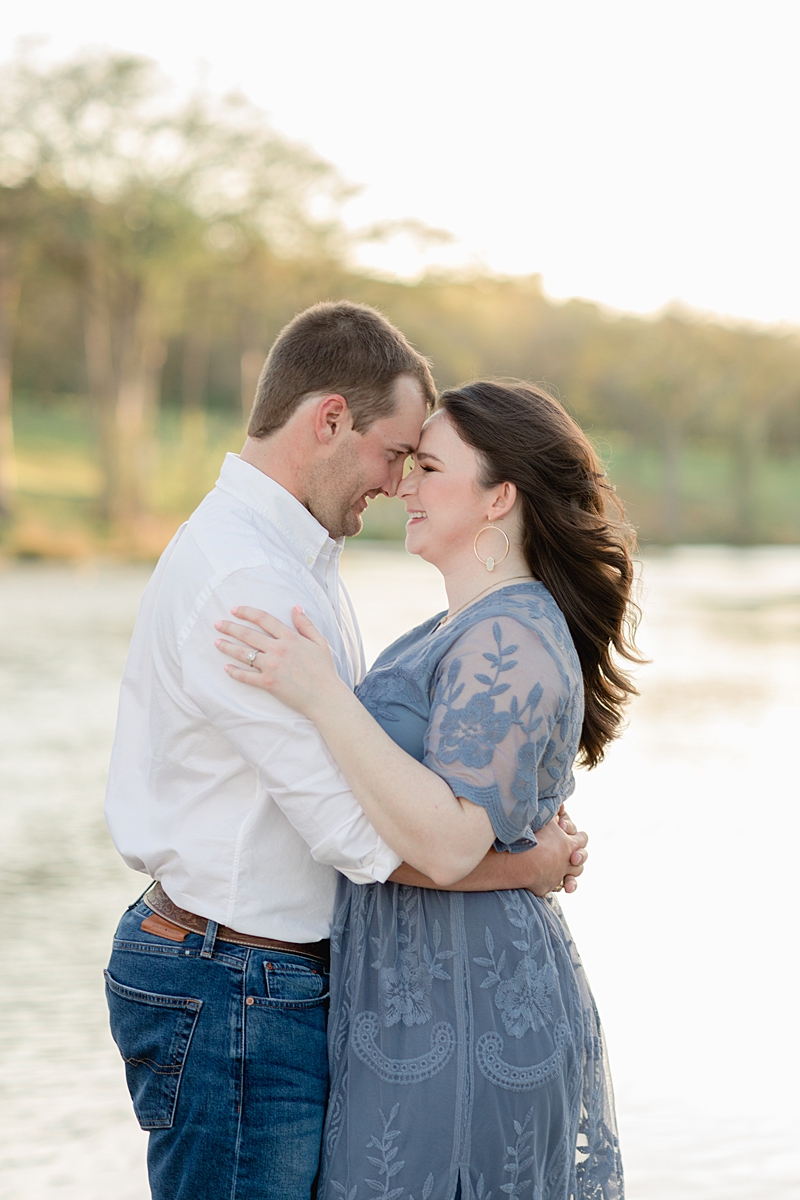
[423, 616, 573, 850]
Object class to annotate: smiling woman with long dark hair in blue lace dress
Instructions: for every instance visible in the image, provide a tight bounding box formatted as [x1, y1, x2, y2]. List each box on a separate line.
[218, 383, 636, 1200]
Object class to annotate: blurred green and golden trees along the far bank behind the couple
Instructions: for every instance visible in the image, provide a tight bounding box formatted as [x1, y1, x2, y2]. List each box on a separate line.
[0, 45, 800, 544]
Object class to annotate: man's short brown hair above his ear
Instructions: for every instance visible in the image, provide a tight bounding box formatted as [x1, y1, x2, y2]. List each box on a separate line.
[247, 300, 437, 438]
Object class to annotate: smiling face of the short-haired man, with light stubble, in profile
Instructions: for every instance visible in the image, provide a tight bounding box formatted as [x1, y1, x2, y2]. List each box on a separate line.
[308, 376, 426, 538]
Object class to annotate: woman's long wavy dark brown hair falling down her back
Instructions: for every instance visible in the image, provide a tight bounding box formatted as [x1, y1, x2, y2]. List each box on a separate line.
[437, 380, 643, 767]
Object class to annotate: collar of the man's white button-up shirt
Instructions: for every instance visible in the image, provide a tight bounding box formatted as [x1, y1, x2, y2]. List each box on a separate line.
[216, 454, 344, 568]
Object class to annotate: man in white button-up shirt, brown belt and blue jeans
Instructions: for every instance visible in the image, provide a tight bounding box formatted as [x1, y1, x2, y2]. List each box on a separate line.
[107, 302, 585, 1200]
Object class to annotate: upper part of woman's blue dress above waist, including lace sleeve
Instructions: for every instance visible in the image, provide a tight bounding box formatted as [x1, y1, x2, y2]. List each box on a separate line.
[357, 581, 583, 850]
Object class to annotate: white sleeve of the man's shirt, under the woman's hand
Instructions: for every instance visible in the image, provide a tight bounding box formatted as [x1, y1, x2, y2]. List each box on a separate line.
[178, 568, 402, 883]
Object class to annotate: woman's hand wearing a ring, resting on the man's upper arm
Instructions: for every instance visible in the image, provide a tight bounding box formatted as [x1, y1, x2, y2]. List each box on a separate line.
[215, 605, 349, 719]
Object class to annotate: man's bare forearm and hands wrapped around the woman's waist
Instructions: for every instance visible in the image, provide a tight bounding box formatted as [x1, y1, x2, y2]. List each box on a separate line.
[390, 810, 589, 896]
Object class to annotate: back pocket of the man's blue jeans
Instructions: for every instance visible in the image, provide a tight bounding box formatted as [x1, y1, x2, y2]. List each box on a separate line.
[103, 971, 203, 1129]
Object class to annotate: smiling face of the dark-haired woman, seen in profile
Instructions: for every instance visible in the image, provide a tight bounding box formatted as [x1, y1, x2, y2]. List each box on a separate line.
[397, 412, 493, 572]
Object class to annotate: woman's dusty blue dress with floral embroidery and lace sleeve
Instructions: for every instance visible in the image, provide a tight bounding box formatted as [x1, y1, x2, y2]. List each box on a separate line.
[318, 582, 622, 1200]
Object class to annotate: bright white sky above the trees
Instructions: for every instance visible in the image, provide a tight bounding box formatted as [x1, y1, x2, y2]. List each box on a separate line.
[0, 0, 800, 323]
